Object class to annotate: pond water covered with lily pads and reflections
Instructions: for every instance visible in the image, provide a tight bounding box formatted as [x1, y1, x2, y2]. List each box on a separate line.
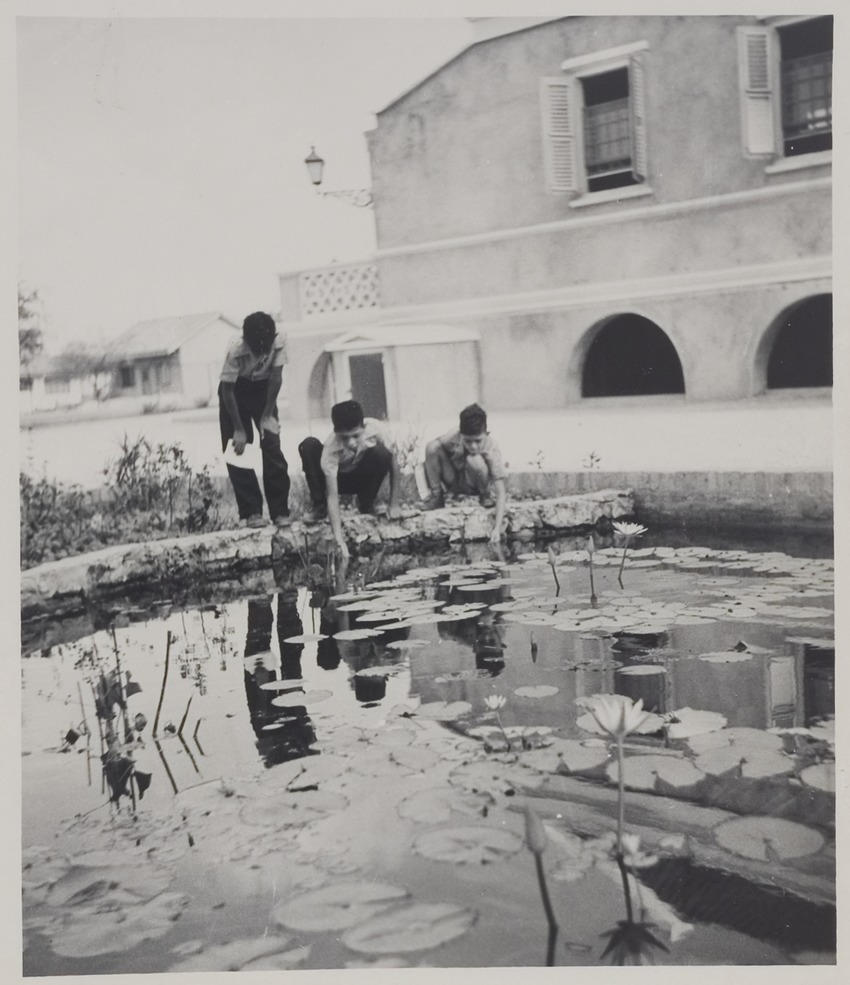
[22, 538, 835, 975]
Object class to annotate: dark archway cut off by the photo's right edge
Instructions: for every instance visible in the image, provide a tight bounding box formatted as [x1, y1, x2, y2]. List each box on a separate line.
[767, 294, 832, 390]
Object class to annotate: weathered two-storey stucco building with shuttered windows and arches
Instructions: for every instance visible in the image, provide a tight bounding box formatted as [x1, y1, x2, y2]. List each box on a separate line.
[280, 16, 832, 416]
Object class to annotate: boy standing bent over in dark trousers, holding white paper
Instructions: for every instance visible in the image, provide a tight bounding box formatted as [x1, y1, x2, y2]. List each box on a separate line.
[218, 311, 291, 527]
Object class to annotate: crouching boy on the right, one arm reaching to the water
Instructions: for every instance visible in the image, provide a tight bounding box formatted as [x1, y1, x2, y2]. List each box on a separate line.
[423, 404, 507, 544]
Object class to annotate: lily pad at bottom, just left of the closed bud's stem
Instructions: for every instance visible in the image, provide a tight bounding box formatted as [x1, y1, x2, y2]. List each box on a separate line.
[342, 903, 477, 954]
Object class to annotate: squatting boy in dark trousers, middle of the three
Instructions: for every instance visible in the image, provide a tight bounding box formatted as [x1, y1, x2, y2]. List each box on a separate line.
[298, 400, 401, 558]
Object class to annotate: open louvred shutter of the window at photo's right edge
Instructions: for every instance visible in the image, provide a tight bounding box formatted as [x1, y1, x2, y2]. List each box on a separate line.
[738, 27, 776, 157]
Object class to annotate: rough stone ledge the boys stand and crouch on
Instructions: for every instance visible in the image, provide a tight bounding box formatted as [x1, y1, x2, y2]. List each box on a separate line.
[21, 489, 634, 618]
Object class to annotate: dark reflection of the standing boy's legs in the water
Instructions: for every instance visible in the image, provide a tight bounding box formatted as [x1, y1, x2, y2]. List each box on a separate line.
[244, 589, 316, 767]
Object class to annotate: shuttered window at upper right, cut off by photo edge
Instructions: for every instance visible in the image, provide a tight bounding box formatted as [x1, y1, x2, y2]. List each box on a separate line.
[739, 17, 832, 158]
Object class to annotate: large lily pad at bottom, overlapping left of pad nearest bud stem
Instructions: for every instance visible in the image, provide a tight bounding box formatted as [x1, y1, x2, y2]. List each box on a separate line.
[274, 880, 410, 932]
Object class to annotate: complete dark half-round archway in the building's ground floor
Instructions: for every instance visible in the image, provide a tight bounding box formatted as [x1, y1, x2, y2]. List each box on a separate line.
[581, 314, 685, 397]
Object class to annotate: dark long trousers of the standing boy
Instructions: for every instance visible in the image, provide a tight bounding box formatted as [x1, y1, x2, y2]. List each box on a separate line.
[218, 379, 289, 520]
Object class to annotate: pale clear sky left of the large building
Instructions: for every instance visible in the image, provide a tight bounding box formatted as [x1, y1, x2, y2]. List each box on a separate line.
[15, 16, 471, 354]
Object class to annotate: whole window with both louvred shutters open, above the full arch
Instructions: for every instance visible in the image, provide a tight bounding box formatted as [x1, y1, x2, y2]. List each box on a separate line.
[541, 42, 647, 193]
